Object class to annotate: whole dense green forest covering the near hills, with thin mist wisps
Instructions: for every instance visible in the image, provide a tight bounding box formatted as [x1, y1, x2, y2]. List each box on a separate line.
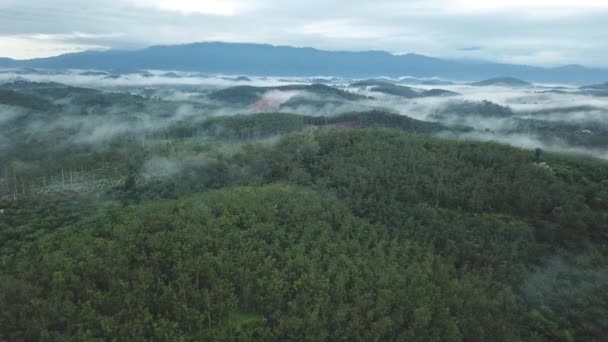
[0, 81, 608, 341]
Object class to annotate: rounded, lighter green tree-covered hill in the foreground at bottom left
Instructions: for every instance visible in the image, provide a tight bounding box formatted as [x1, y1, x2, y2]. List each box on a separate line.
[0, 186, 521, 341]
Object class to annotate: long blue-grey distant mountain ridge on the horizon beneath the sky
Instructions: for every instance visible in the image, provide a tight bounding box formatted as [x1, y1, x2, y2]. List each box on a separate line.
[0, 42, 608, 84]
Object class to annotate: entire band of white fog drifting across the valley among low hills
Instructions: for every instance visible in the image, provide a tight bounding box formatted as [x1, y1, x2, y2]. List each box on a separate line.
[0, 70, 608, 163]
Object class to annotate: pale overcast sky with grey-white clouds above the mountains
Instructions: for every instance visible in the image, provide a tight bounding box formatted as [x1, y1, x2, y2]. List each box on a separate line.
[0, 0, 608, 67]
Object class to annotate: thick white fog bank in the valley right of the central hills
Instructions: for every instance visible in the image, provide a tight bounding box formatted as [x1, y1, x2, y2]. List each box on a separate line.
[347, 85, 608, 159]
